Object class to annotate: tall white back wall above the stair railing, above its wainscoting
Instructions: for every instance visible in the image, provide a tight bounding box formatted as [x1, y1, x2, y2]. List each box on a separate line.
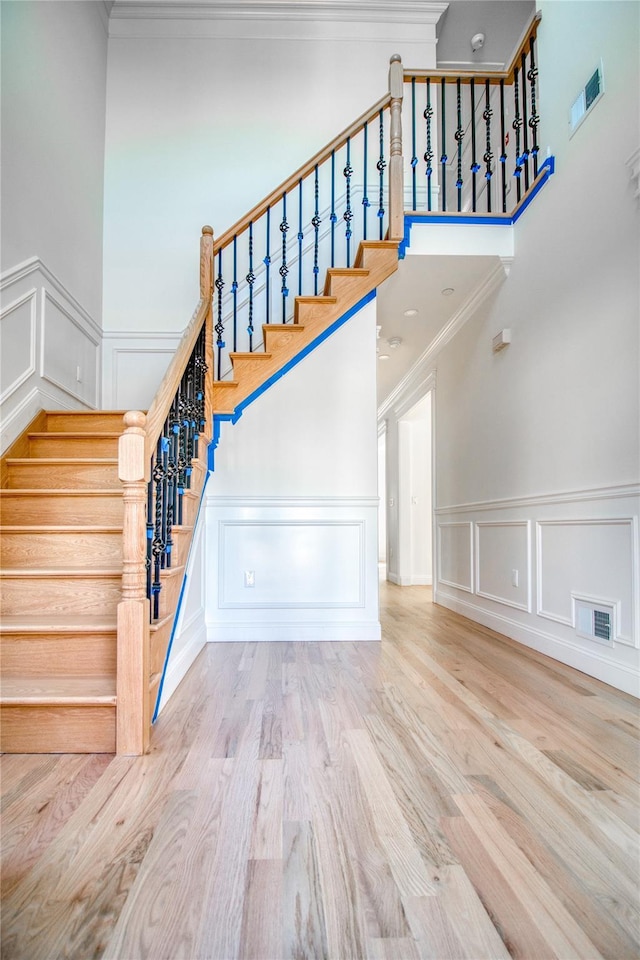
[104, 4, 442, 342]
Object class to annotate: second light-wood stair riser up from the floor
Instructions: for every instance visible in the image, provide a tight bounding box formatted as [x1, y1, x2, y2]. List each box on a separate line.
[0, 630, 116, 679]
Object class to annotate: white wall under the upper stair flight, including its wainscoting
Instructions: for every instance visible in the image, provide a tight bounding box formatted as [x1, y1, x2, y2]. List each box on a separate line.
[205, 301, 380, 640]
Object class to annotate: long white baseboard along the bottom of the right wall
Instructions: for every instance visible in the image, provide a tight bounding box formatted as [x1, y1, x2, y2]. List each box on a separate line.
[437, 591, 640, 697]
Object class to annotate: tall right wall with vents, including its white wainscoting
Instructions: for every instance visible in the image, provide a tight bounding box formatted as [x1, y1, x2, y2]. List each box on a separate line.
[436, 2, 640, 693]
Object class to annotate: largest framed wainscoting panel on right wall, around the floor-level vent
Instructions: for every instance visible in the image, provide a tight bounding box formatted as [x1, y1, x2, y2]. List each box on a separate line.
[536, 517, 638, 645]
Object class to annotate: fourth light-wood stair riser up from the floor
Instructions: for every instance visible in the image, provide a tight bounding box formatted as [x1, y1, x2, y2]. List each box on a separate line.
[2, 532, 122, 568]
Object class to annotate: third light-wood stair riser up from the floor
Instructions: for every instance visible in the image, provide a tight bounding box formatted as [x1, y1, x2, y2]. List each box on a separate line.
[0, 577, 122, 616]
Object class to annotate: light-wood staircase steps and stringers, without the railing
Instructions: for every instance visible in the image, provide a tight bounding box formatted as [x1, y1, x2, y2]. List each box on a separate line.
[0, 241, 398, 753]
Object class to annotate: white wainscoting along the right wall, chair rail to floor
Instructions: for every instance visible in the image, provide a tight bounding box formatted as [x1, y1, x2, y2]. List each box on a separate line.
[434, 484, 640, 696]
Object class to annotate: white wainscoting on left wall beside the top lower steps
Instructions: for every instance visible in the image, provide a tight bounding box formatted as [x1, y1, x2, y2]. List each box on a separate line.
[0, 257, 102, 451]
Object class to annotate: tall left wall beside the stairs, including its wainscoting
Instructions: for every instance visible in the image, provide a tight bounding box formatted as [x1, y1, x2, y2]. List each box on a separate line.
[0, 0, 107, 450]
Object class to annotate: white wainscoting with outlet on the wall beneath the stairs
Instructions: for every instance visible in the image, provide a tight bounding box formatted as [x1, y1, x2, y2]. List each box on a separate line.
[205, 498, 380, 640]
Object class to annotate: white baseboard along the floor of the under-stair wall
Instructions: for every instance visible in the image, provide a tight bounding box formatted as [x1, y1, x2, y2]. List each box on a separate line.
[207, 620, 381, 643]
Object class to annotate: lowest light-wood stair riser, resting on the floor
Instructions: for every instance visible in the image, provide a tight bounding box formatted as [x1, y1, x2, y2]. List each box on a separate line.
[0, 705, 116, 753]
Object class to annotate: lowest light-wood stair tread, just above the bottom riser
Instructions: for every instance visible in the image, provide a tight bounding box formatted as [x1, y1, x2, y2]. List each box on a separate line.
[0, 677, 116, 706]
